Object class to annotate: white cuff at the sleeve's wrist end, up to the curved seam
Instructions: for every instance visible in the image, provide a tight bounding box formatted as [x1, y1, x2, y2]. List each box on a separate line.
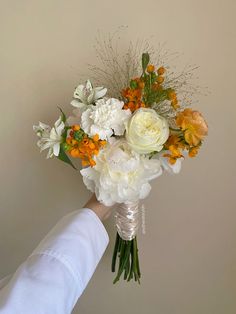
[31, 208, 109, 289]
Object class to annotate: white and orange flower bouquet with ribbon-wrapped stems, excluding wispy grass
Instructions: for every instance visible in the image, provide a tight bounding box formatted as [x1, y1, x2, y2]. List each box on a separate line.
[33, 47, 208, 283]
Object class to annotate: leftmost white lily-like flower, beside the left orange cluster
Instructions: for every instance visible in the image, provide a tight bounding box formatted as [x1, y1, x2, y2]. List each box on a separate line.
[33, 117, 65, 158]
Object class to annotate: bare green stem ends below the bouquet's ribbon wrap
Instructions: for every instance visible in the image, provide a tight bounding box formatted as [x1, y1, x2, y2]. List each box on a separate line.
[111, 232, 141, 284]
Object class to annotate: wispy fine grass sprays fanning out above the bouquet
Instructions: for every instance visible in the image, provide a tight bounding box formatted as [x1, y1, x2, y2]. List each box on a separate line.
[89, 28, 206, 122]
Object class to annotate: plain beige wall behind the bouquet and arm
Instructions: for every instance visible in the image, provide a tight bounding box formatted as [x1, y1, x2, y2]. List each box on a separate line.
[0, 0, 236, 314]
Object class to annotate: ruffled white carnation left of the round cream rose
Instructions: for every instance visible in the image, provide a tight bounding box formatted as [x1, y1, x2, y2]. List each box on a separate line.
[81, 98, 131, 140]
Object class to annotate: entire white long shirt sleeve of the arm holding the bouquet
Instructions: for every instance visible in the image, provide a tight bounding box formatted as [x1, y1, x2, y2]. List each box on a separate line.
[0, 208, 109, 314]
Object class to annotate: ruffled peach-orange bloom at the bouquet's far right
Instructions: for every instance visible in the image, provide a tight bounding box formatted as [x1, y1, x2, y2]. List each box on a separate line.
[176, 108, 208, 146]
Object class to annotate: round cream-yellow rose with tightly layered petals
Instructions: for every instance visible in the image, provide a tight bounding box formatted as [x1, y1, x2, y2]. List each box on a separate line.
[126, 108, 169, 154]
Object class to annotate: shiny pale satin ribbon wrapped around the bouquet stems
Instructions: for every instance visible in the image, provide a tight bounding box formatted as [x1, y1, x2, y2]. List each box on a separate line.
[115, 201, 140, 241]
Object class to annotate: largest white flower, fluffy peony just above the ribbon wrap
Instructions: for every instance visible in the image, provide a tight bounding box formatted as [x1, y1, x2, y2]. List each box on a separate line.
[80, 139, 162, 206]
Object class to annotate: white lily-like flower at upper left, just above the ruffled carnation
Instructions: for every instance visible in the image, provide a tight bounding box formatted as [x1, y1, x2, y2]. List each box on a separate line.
[71, 80, 107, 110]
